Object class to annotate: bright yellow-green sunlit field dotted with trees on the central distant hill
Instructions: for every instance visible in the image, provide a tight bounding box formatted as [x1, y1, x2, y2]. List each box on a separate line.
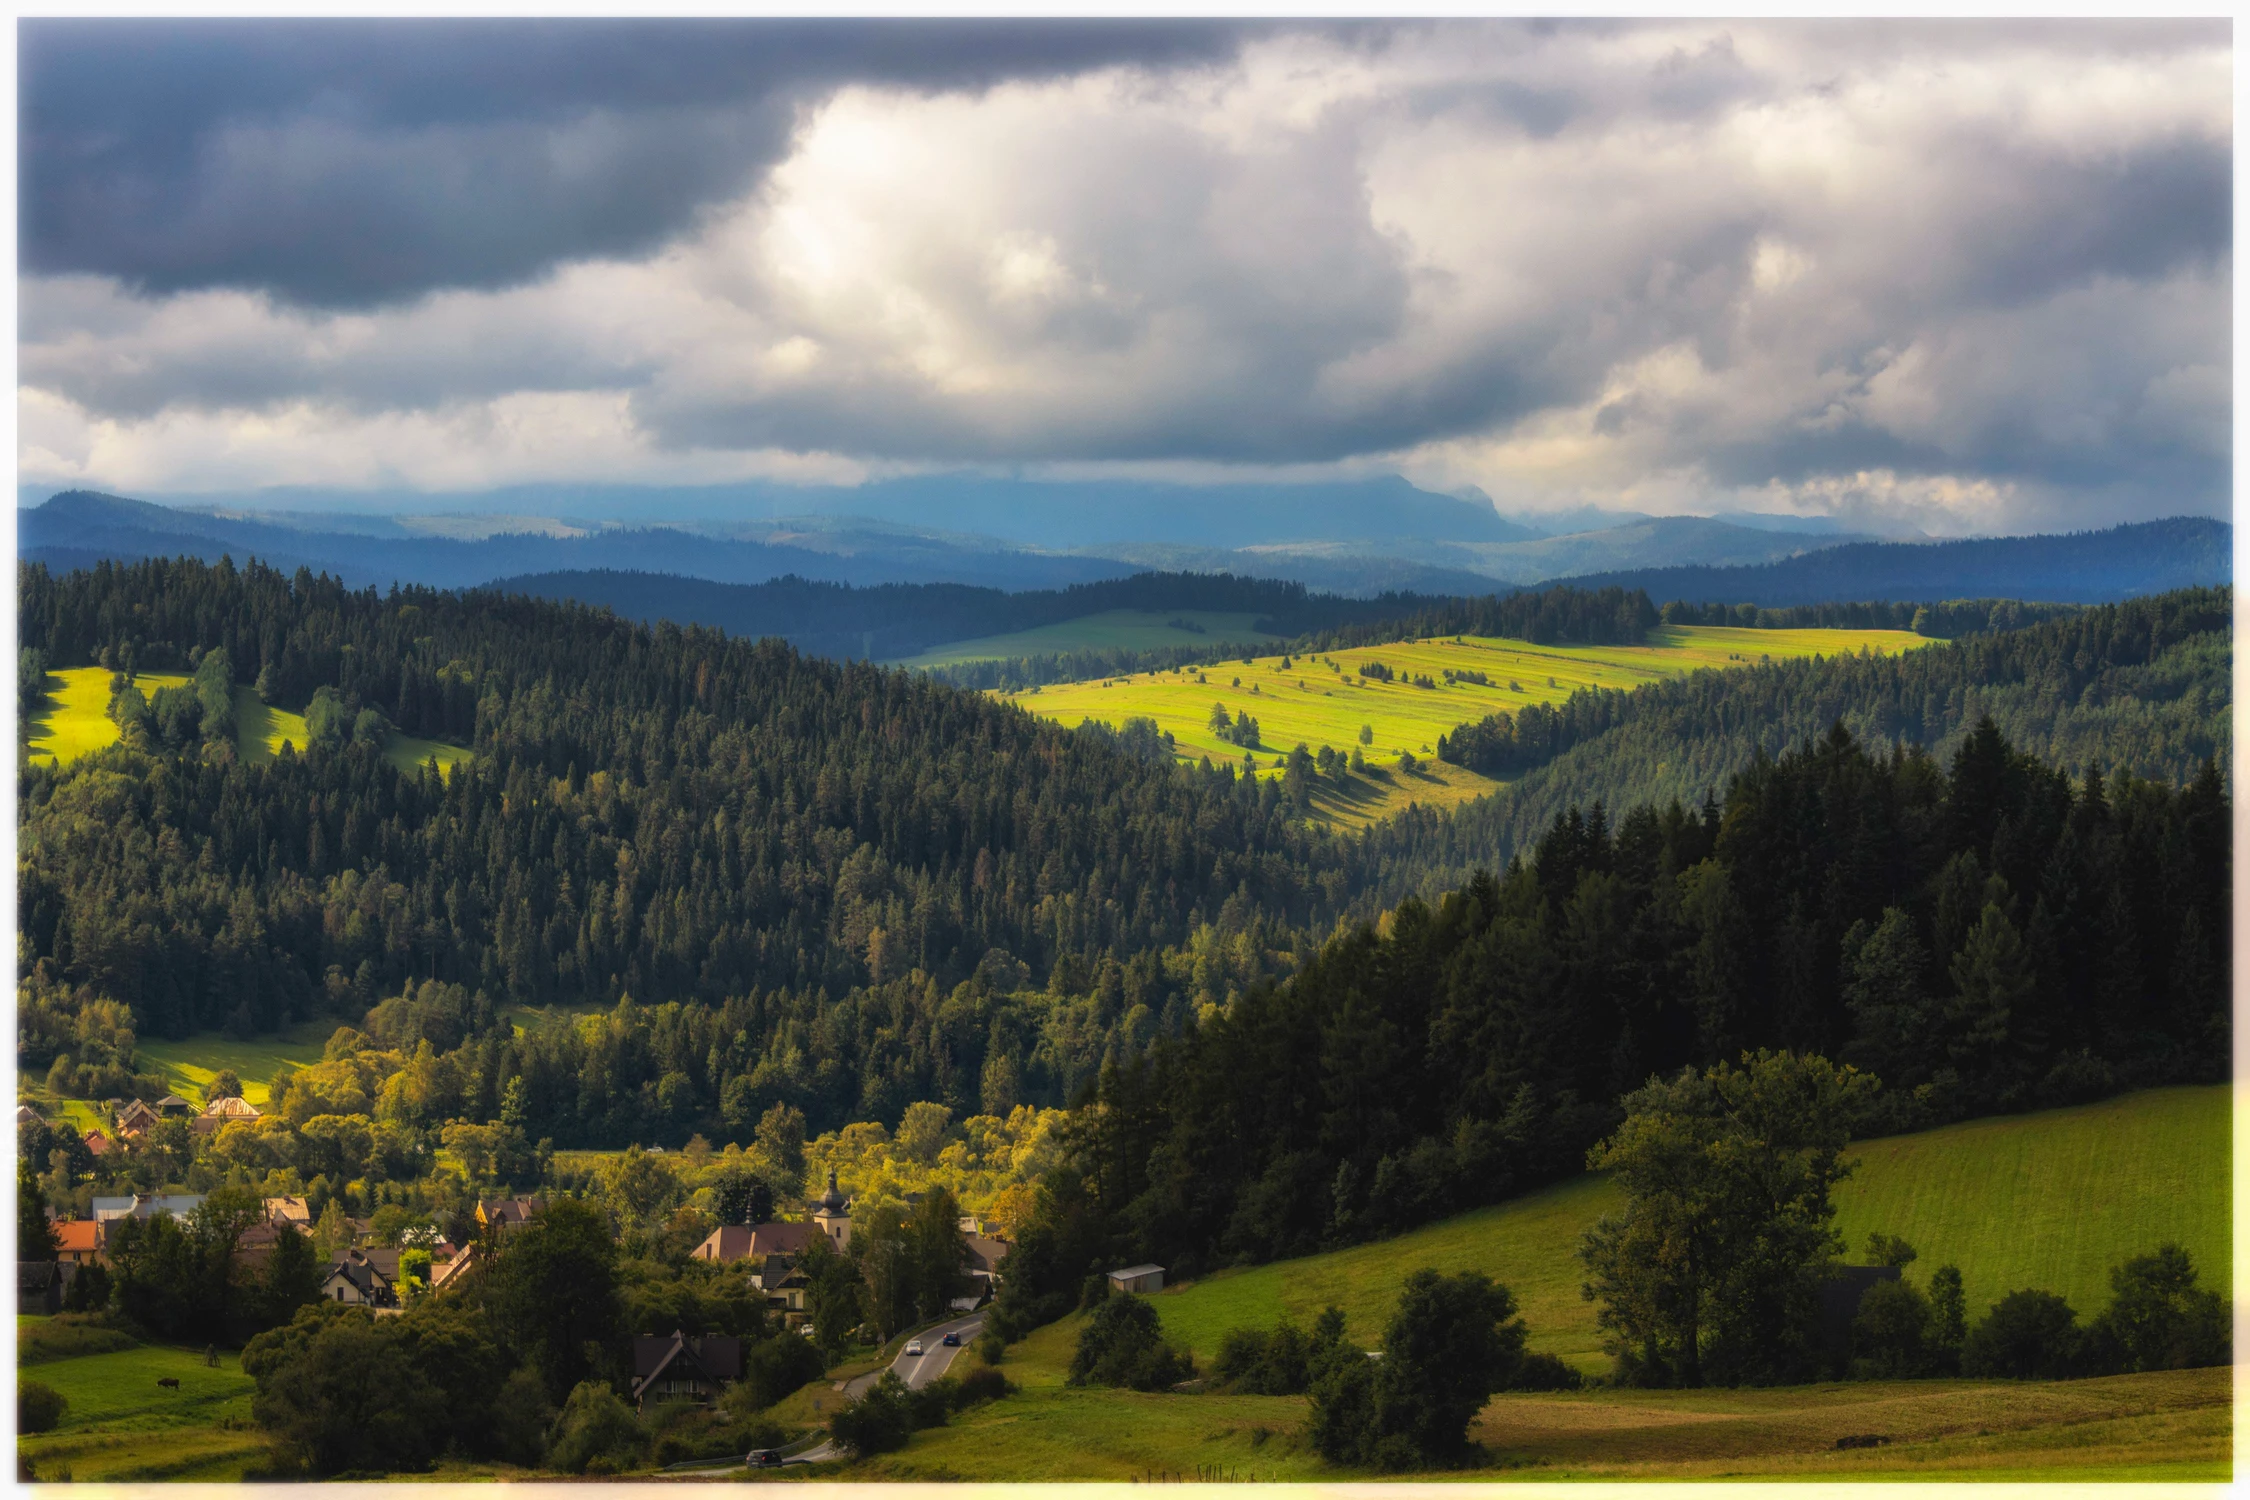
[1001, 625, 1933, 823]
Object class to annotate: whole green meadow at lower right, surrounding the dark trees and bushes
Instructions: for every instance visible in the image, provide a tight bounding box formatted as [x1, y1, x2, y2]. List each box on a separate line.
[806, 1088, 2234, 1482]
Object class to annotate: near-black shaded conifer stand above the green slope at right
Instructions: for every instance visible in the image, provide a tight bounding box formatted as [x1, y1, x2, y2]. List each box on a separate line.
[1013, 722, 2230, 1320]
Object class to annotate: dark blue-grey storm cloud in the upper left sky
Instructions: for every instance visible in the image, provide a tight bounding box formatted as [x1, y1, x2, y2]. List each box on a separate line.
[18, 20, 1269, 306]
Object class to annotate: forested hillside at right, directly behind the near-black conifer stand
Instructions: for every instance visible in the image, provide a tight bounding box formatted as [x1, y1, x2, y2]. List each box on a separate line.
[1368, 589, 2234, 900]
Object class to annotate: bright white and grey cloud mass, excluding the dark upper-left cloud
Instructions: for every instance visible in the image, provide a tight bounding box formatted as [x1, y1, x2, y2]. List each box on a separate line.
[18, 25, 2232, 531]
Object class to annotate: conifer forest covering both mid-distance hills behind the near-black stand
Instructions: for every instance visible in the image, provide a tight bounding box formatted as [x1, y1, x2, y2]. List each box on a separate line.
[18, 562, 2225, 1145]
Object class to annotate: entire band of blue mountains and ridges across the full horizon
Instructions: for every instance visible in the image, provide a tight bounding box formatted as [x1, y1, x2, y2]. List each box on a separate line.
[18, 494, 2232, 657]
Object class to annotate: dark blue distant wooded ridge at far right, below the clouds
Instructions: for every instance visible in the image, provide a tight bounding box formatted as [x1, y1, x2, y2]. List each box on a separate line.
[1555, 515, 2234, 605]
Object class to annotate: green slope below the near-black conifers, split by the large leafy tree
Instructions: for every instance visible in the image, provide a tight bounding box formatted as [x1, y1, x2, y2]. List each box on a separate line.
[1154, 1086, 2232, 1370]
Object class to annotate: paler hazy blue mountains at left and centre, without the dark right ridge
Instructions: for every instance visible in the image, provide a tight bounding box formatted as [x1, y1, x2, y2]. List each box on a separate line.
[18, 479, 1820, 596]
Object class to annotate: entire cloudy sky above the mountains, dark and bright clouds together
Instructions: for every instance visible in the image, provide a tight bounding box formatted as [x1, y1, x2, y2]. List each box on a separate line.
[18, 20, 2232, 535]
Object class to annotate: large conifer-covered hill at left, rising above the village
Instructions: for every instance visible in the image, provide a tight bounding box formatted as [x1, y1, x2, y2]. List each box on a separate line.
[18, 560, 1357, 1056]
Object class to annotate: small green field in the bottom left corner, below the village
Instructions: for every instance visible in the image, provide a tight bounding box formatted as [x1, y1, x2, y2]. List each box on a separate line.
[16, 1320, 266, 1482]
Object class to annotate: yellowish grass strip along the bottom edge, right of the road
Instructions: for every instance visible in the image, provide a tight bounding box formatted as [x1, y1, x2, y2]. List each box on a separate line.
[846, 1316, 2232, 1482]
